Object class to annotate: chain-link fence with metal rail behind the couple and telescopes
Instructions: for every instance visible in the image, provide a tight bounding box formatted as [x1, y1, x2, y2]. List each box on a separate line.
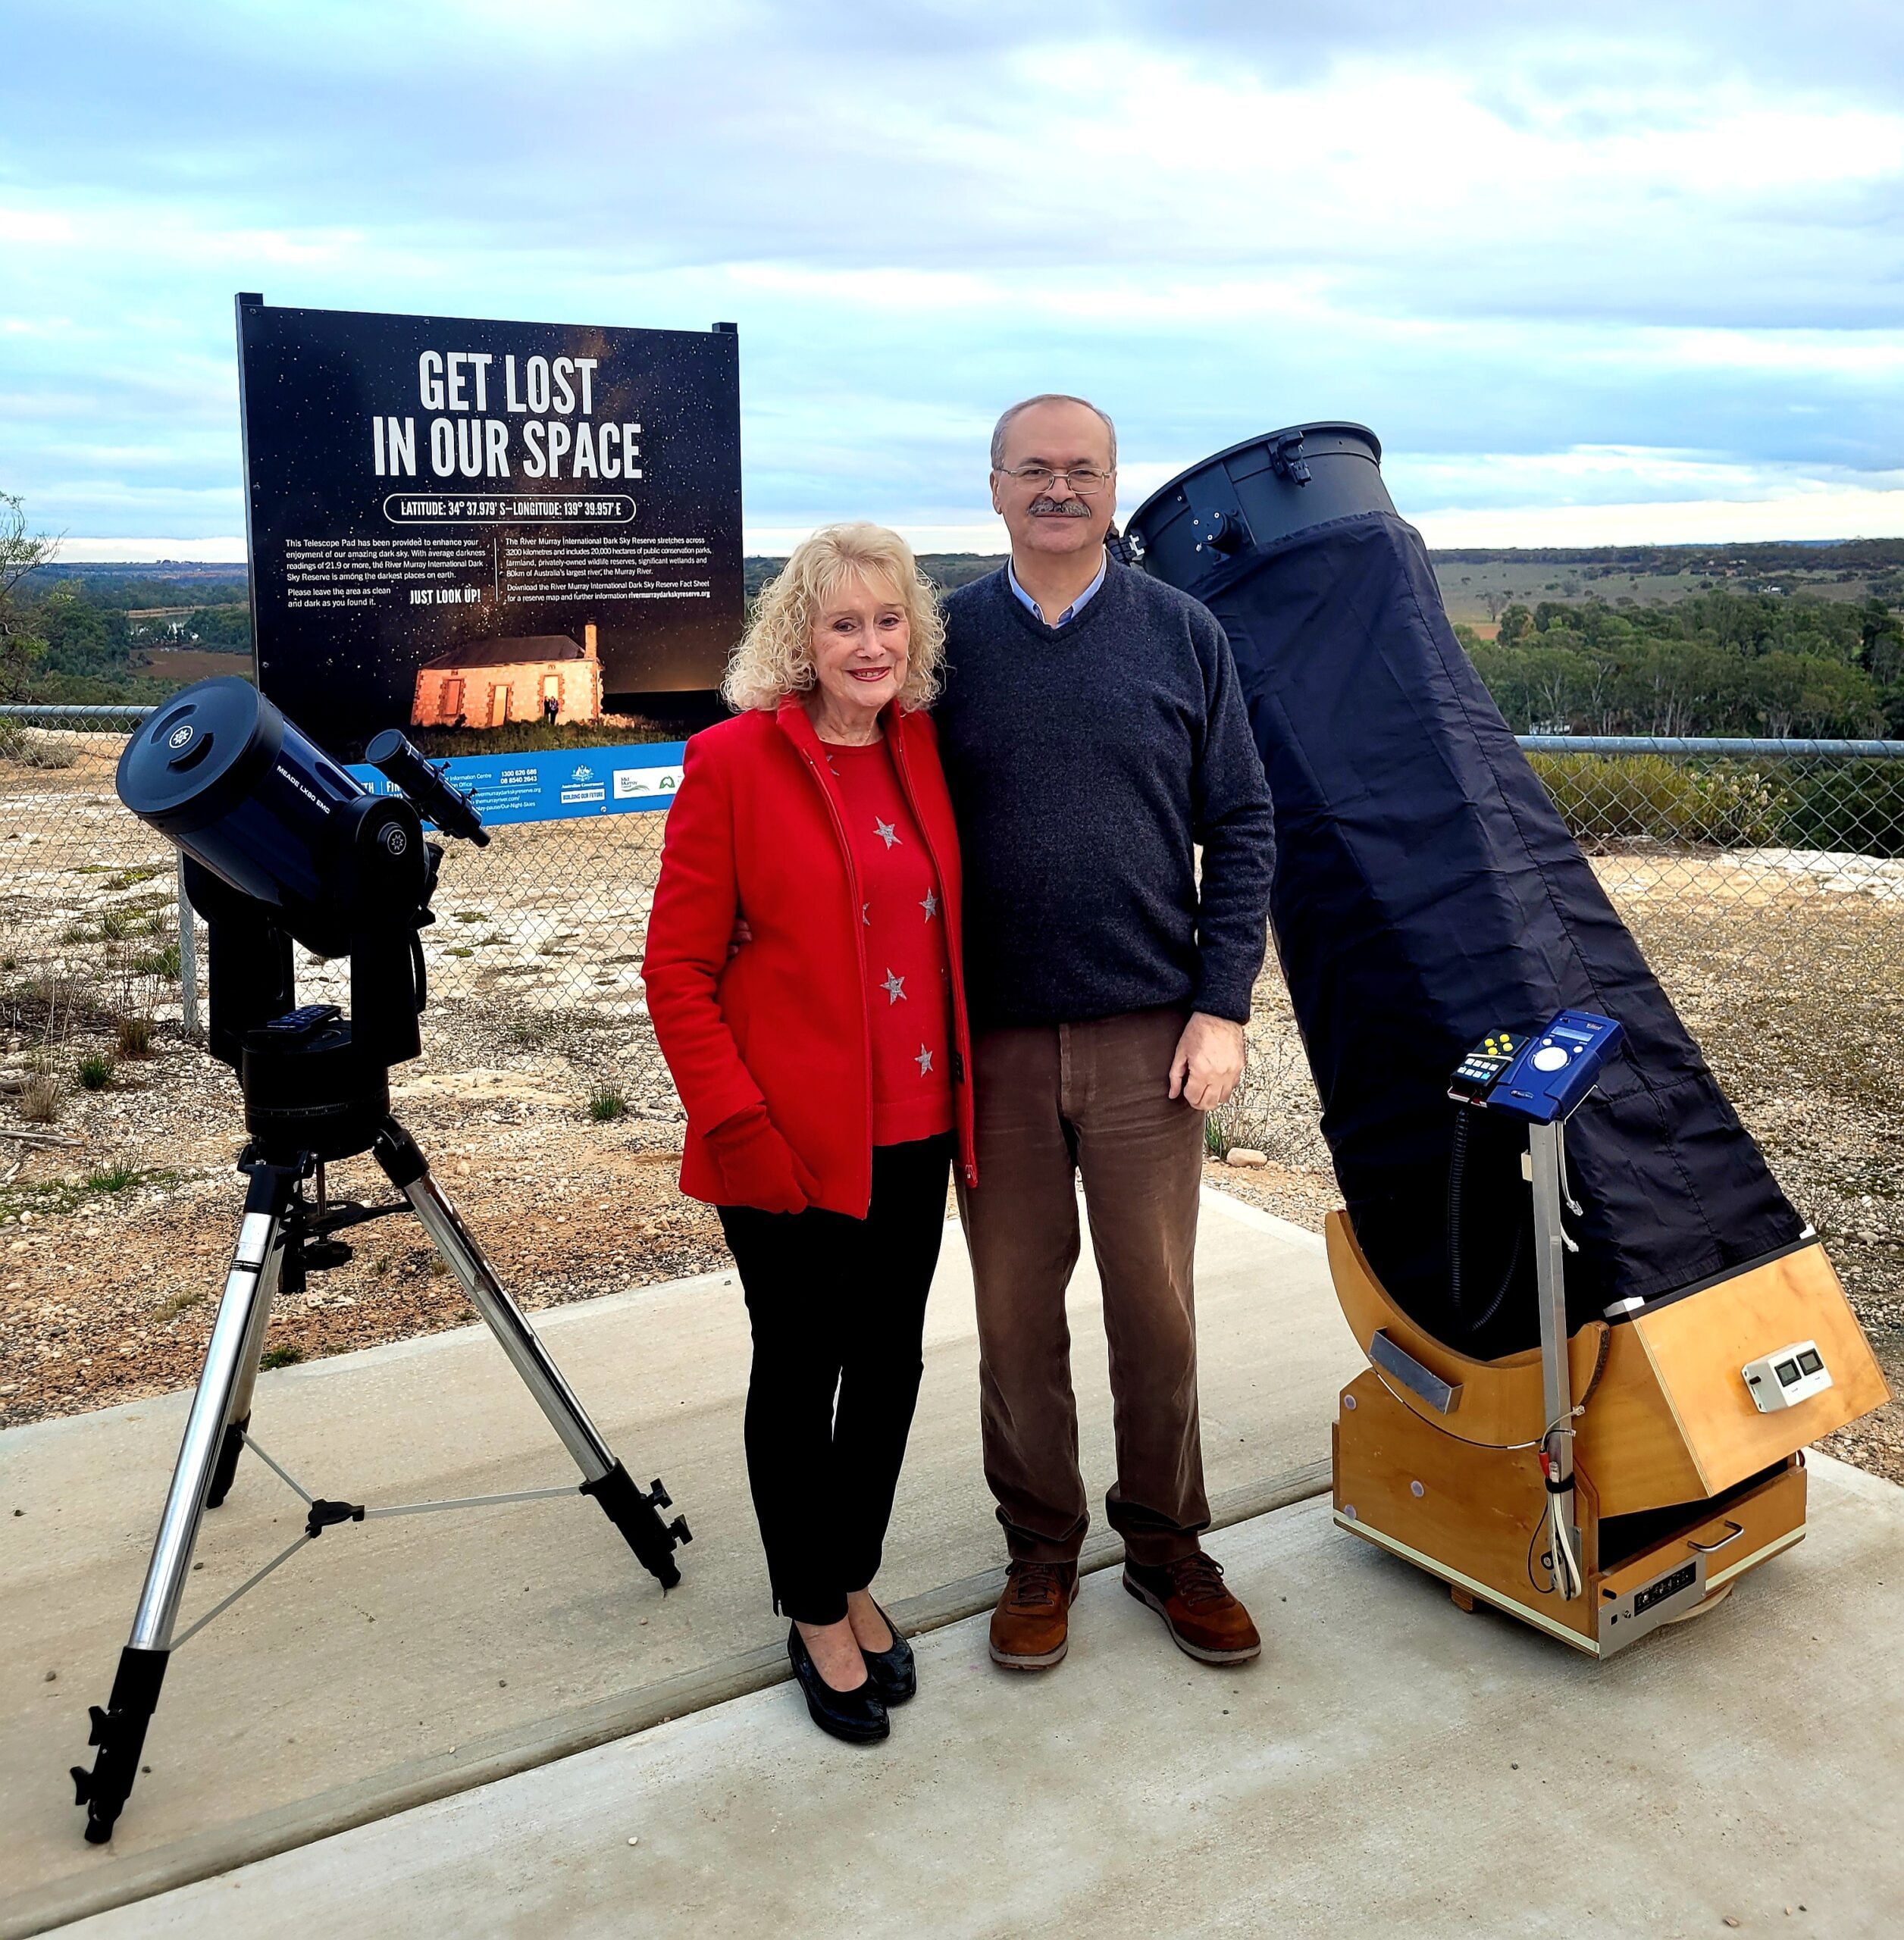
[0, 708, 1904, 1125]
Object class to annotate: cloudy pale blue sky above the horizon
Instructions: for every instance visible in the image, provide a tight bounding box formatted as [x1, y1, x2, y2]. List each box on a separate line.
[0, 0, 1904, 557]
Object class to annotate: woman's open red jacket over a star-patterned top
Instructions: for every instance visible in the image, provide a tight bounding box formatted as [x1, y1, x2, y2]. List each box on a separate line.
[643, 699, 979, 1219]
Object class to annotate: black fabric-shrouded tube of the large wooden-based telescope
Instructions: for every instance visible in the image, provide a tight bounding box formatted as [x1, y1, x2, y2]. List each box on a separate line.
[1126, 425, 1803, 1354]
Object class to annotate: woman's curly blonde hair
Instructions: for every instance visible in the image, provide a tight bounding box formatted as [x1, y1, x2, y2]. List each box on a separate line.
[720, 522, 945, 712]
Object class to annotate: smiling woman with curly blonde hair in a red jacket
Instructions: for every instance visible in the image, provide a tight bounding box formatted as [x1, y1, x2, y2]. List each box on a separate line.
[643, 526, 974, 1742]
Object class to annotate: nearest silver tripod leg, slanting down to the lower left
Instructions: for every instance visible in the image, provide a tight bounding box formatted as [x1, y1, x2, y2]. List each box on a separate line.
[72, 1166, 297, 1845]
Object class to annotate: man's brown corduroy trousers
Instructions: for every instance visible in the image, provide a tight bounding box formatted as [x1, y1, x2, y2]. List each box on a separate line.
[959, 1009, 1209, 1563]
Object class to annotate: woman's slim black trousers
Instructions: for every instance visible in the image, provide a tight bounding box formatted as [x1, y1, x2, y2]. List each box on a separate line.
[718, 1133, 953, 1624]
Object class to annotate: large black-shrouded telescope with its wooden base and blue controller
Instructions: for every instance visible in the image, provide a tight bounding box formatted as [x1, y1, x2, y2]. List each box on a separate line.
[1124, 436, 1887, 1657]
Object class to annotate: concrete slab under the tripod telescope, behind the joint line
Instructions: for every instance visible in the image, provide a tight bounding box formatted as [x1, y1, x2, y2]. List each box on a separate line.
[0, 1193, 1363, 1936]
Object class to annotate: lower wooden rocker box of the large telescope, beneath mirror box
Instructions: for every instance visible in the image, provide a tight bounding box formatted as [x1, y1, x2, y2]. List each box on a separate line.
[1333, 1368, 1805, 1657]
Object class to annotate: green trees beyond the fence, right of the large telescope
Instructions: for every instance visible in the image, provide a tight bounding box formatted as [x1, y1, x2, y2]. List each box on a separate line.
[1455, 590, 1904, 737]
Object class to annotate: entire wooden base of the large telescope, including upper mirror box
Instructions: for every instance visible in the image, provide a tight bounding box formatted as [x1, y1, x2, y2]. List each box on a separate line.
[1327, 1212, 1889, 1657]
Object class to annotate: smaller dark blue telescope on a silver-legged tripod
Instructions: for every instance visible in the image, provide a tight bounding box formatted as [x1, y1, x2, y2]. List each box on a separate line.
[74, 679, 689, 1845]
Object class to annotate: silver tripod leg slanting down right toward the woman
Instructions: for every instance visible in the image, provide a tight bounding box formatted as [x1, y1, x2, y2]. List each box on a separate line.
[374, 1118, 693, 1589]
